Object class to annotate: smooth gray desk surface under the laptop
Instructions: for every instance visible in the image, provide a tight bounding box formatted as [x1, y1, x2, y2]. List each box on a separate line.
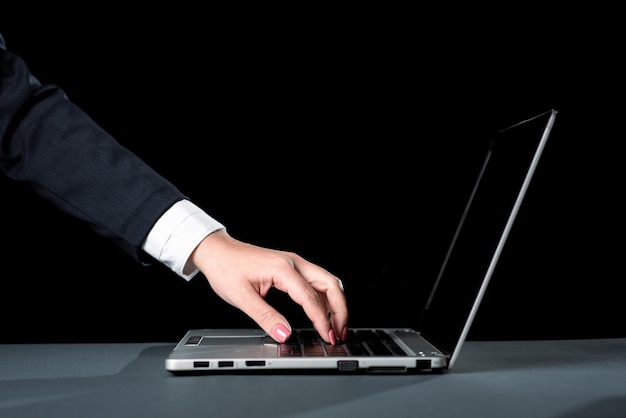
[0, 338, 626, 418]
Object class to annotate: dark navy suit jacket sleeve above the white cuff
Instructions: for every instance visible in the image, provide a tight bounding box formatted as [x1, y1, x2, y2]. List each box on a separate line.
[0, 34, 185, 261]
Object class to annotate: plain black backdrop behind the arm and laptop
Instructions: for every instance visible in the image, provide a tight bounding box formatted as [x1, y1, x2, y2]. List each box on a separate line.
[0, 6, 626, 342]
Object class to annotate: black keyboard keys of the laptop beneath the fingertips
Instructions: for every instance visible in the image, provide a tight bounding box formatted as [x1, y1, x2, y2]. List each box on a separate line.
[280, 330, 406, 357]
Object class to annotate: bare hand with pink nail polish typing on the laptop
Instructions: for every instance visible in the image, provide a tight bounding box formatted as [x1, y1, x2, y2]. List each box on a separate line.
[190, 230, 348, 345]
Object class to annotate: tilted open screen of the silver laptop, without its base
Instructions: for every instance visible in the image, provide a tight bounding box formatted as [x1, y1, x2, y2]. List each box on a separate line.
[417, 110, 556, 360]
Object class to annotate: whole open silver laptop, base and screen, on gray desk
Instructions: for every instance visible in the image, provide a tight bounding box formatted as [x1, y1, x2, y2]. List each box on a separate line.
[165, 109, 557, 374]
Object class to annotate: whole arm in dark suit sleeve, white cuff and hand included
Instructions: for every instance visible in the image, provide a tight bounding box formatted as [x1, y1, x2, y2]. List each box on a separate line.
[0, 35, 348, 343]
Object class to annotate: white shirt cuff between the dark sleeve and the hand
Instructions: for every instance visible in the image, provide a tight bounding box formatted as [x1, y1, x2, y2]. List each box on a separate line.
[143, 200, 224, 280]
